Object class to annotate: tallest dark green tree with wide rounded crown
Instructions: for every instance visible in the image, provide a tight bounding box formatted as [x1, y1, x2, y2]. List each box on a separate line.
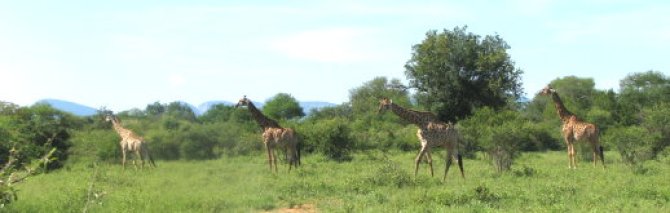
[405, 27, 523, 121]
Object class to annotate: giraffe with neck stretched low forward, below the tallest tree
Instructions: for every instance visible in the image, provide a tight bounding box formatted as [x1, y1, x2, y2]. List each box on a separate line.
[378, 98, 465, 181]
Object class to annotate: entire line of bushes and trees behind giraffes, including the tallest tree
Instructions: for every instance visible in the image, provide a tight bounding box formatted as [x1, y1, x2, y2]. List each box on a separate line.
[0, 27, 670, 173]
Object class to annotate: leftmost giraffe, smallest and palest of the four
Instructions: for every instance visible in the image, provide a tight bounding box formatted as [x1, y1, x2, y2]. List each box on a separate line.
[105, 114, 156, 169]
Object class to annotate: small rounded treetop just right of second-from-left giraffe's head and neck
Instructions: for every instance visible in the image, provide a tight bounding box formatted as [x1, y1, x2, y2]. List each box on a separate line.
[263, 93, 305, 120]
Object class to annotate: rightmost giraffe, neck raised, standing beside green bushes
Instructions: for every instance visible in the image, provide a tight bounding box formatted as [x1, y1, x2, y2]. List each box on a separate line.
[539, 85, 605, 169]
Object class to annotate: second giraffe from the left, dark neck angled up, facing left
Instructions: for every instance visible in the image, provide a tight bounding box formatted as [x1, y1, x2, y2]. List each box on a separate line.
[235, 95, 300, 172]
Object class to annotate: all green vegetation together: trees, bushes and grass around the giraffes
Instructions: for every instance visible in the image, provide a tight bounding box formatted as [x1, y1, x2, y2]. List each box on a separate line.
[0, 25, 670, 212]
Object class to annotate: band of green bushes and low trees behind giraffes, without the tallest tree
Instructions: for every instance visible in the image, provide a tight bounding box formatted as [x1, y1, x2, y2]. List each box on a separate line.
[0, 71, 670, 171]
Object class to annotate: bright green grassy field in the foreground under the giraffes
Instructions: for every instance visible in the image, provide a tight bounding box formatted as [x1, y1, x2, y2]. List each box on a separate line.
[6, 152, 670, 212]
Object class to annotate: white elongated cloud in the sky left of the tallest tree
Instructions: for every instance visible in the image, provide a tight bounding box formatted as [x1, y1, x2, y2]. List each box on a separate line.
[271, 28, 373, 62]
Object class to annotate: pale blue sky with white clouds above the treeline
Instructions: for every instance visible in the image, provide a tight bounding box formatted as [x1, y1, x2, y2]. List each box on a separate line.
[0, 0, 670, 111]
